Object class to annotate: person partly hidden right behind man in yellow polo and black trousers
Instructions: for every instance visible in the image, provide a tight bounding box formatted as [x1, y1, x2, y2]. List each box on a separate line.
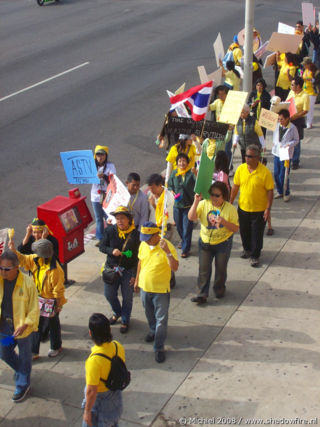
[232, 104, 265, 163]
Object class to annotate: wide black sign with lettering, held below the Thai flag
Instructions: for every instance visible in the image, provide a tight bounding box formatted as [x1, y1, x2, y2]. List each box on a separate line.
[167, 117, 229, 140]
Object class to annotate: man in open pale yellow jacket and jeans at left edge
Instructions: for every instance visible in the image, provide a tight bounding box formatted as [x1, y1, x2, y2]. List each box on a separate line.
[0, 251, 39, 403]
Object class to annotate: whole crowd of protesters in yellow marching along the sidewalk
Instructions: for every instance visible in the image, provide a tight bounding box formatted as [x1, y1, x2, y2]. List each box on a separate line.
[0, 15, 320, 426]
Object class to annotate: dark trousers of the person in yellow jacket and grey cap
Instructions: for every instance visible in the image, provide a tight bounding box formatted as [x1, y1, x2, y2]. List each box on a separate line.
[32, 313, 62, 354]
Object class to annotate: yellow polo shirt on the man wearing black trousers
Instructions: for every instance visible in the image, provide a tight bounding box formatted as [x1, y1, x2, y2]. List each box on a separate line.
[233, 163, 274, 212]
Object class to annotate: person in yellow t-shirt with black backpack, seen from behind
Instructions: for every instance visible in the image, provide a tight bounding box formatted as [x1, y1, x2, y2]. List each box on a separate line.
[82, 313, 125, 427]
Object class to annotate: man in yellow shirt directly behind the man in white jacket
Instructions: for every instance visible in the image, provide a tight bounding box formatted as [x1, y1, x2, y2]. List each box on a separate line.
[287, 77, 310, 169]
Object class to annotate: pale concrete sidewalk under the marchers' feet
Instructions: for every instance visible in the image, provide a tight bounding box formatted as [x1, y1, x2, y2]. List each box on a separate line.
[0, 111, 320, 427]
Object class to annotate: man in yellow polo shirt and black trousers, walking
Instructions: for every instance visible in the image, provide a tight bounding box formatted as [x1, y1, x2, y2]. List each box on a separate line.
[230, 145, 274, 267]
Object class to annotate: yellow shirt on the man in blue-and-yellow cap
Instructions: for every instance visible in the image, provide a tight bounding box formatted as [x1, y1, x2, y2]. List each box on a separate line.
[138, 239, 178, 294]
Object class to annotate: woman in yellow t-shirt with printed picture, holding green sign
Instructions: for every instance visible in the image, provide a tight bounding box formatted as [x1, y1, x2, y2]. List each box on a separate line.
[188, 181, 239, 304]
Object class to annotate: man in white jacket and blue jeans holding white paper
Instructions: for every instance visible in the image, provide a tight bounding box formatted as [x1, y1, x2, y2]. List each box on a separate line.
[272, 109, 299, 202]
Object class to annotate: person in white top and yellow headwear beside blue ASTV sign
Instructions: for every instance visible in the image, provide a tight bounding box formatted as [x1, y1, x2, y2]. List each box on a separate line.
[91, 145, 117, 246]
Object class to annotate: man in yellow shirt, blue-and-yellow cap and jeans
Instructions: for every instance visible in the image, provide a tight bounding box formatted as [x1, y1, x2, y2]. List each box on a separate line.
[134, 222, 179, 363]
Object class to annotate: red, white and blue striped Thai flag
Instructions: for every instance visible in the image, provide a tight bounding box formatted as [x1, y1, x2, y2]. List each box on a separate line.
[170, 81, 213, 122]
